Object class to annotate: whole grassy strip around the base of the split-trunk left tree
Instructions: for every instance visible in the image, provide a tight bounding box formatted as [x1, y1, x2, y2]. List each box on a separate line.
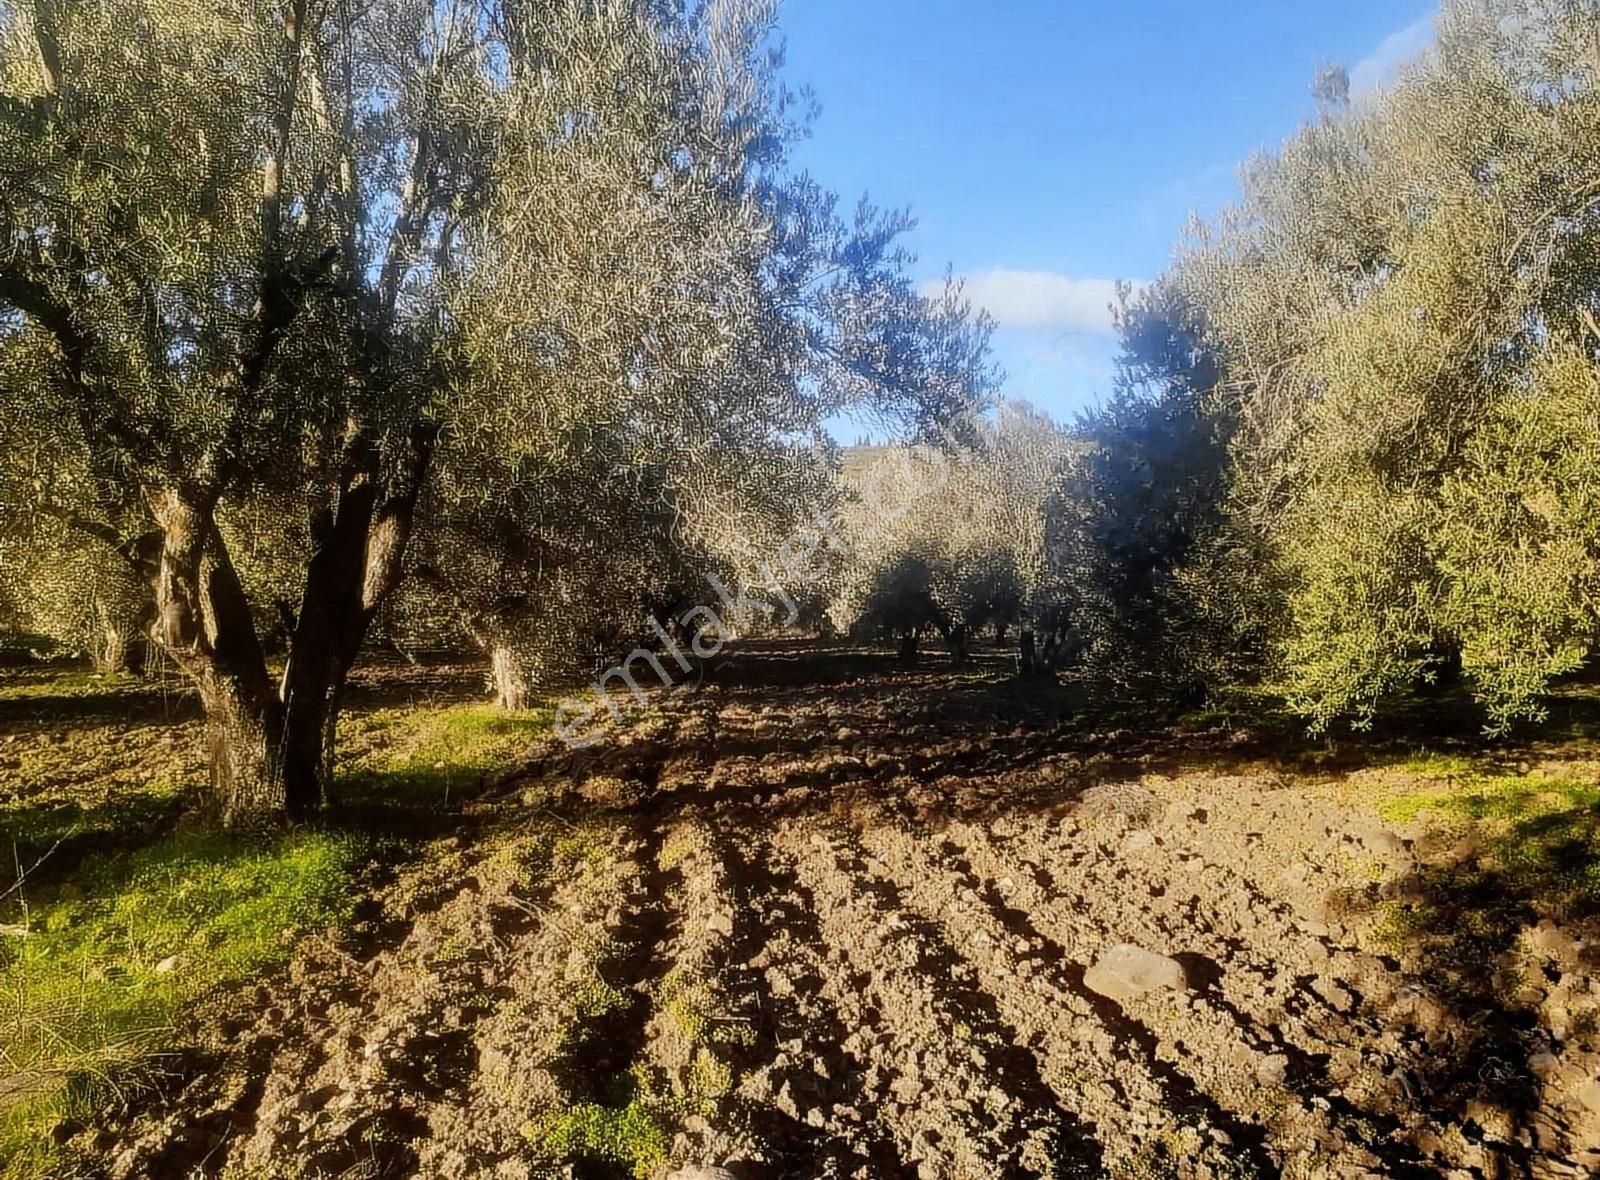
[0, 658, 541, 1177]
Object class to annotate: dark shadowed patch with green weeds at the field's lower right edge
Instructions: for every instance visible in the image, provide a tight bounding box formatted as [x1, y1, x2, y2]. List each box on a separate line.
[1354, 772, 1600, 1175]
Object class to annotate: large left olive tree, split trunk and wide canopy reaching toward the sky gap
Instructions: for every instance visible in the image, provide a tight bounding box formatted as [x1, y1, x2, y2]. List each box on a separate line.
[0, 0, 982, 822]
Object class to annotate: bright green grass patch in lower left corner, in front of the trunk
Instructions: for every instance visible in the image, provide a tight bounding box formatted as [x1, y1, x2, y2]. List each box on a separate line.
[0, 831, 360, 1177]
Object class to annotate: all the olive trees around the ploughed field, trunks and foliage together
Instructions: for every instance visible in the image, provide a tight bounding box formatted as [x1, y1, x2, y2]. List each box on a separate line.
[0, 0, 1600, 820]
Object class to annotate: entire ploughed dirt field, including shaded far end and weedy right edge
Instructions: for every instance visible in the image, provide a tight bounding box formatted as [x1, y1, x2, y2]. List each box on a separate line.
[18, 644, 1600, 1180]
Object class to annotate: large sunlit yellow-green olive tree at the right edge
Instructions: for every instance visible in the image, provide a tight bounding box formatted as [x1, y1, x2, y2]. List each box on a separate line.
[1170, 0, 1600, 729]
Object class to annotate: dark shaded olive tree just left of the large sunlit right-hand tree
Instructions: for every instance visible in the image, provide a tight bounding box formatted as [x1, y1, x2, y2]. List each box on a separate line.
[1043, 283, 1270, 700]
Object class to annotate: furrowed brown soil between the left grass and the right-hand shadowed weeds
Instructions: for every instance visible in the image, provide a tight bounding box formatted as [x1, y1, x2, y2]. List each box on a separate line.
[78, 649, 1587, 1180]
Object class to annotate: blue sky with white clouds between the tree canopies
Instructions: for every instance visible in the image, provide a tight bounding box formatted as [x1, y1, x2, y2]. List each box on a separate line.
[782, 0, 1434, 431]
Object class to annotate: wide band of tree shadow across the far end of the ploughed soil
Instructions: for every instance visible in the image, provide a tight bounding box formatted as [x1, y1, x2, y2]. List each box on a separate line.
[512, 640, 1600, 820]
